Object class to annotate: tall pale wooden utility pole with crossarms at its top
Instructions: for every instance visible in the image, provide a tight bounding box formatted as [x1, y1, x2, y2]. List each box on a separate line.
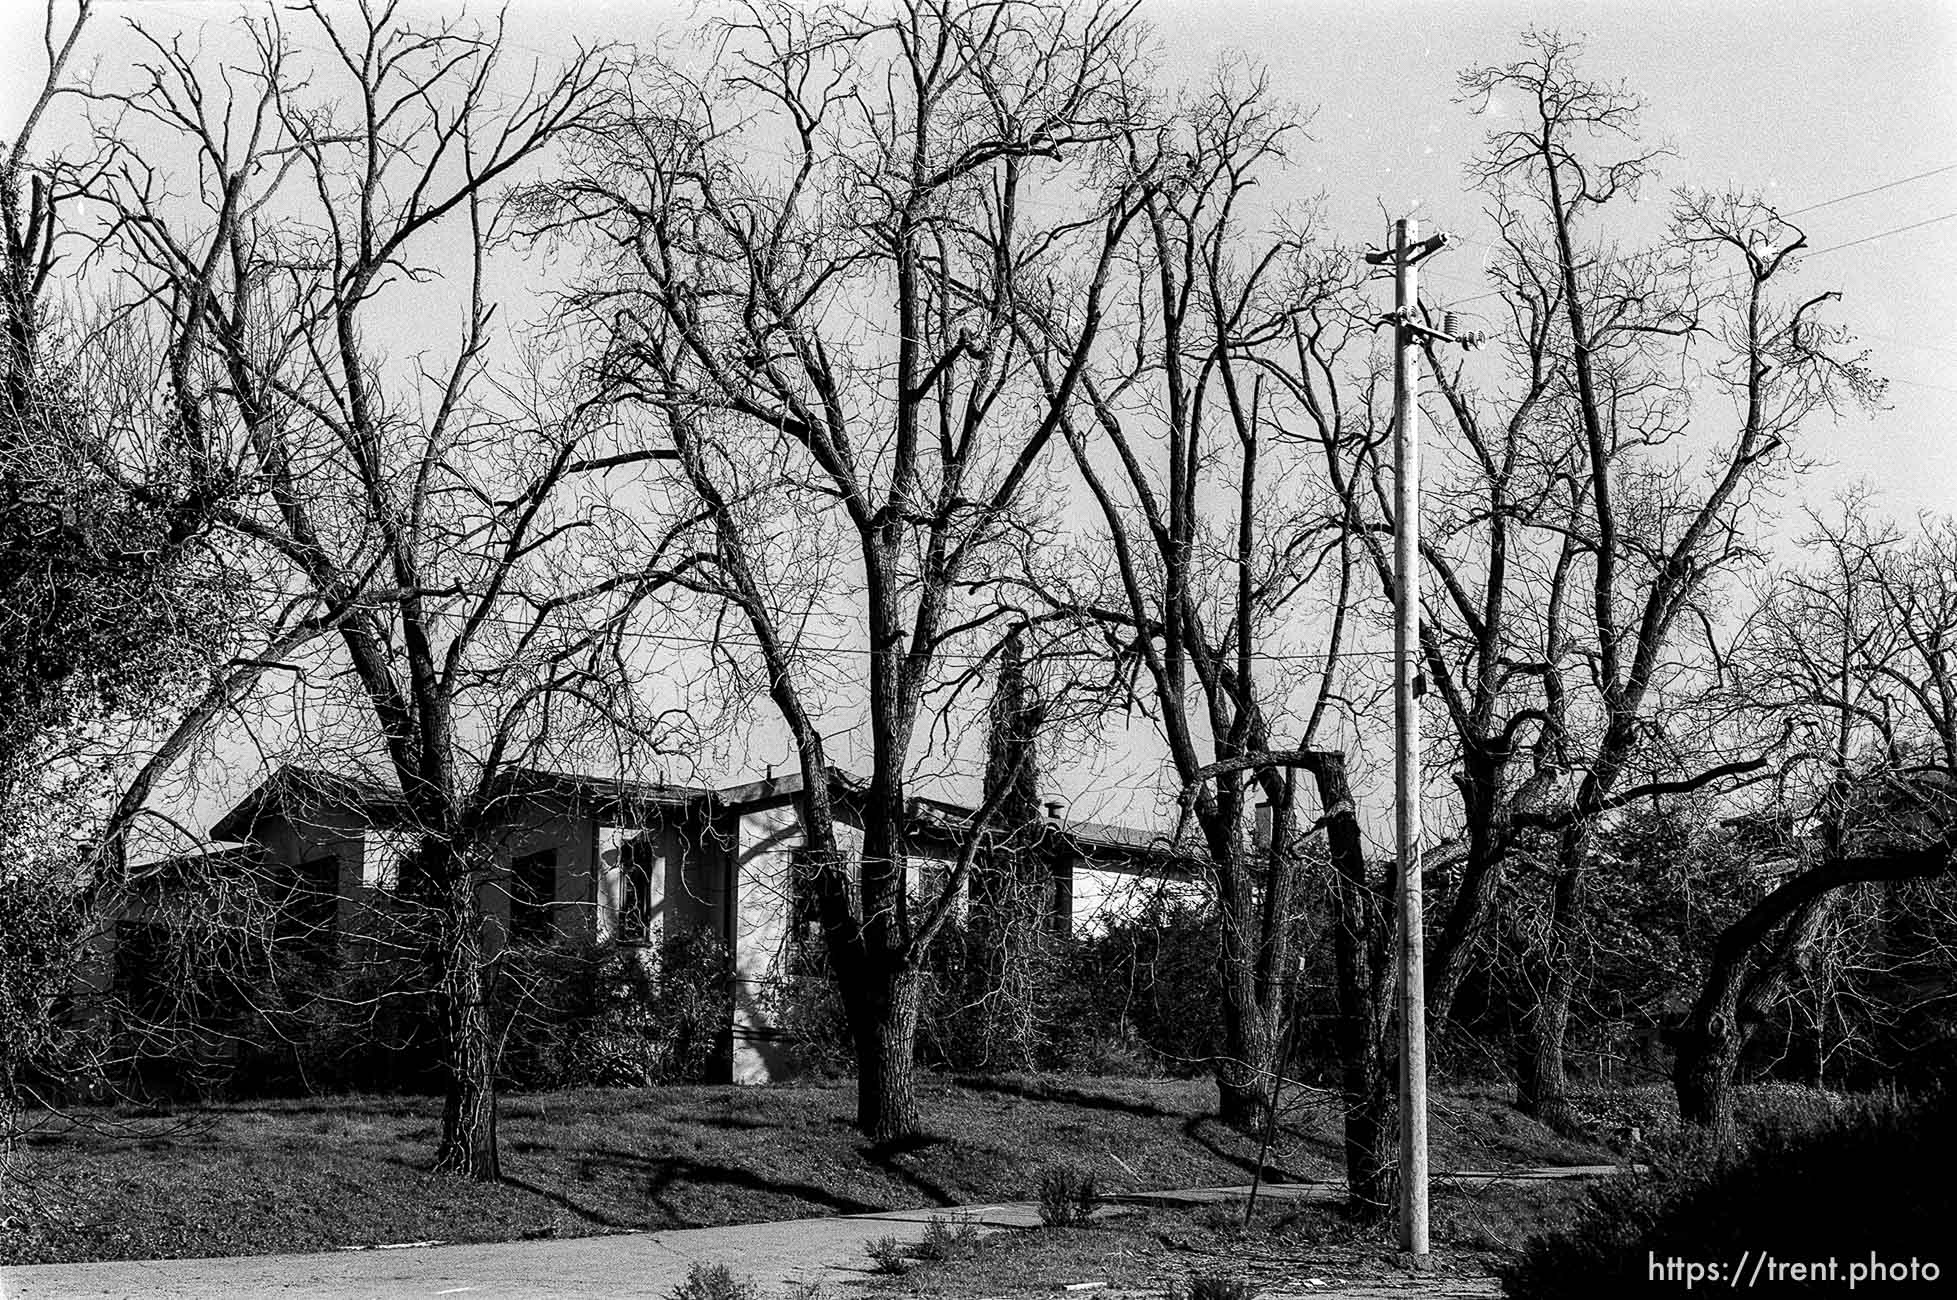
[1366, 217, 1481, 1267]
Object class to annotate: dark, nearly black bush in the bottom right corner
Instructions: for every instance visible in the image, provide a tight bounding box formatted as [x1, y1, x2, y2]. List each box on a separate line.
[1503, 1100, 1957, 1300]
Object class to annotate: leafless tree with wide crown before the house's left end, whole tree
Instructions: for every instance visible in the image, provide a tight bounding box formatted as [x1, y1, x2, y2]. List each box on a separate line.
[98, 4, 637, 1179]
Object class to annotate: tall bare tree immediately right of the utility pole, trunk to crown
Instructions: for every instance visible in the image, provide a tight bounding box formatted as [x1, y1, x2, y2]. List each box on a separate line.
[1462, 33, 1875, 1120]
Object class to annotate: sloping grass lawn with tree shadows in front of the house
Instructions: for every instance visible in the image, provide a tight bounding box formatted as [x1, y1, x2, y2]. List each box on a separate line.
[0, 1077, 1611, 1263]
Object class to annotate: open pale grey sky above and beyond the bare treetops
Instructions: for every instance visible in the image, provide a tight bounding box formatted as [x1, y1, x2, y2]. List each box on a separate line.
[0, 0, 1957, 853]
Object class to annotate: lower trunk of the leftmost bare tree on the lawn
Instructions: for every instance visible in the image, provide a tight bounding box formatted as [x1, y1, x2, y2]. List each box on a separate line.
[434, 861, 503, 1183]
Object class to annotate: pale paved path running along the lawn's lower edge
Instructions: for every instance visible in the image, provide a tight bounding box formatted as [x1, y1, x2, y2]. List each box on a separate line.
[0, 1165, 1613, 1300]
